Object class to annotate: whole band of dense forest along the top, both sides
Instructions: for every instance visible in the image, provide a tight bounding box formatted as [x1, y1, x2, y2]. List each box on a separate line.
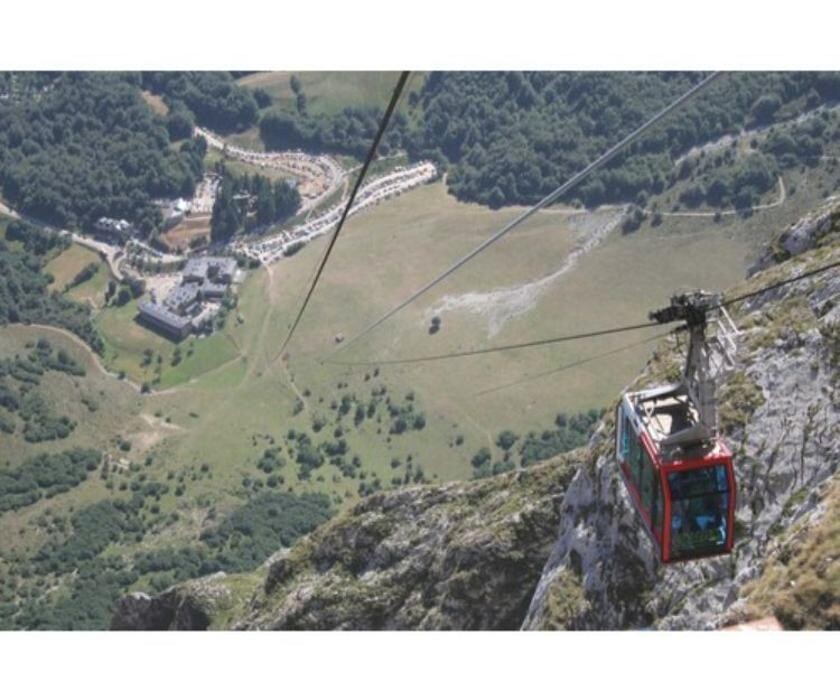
[0, 72, 840, 233]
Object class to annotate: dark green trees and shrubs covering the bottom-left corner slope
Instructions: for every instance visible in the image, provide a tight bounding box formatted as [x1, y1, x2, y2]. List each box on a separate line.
[0, 460, 272, 629]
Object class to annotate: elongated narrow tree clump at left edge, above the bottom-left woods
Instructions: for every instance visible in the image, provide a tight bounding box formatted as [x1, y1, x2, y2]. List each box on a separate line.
[0, 448, 102, 513]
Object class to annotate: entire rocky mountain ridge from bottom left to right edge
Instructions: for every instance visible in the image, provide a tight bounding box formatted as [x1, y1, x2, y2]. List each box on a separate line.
[113, 209, 840, 629]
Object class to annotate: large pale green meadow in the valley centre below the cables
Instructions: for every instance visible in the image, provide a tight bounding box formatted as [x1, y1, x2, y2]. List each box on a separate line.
[98, 144, 832, 498]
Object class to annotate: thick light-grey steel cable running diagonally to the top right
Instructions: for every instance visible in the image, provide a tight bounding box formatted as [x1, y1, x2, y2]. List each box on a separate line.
[331, 72, 721, 355]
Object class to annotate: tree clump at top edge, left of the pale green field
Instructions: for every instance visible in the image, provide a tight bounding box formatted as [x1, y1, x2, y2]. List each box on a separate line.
[142, 71, 265, 138]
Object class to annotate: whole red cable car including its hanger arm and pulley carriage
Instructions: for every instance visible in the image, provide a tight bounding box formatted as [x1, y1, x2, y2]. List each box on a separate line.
[615, 292, 737, 563]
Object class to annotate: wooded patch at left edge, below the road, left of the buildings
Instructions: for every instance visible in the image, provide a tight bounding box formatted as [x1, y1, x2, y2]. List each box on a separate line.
[0, 227, 105, 354]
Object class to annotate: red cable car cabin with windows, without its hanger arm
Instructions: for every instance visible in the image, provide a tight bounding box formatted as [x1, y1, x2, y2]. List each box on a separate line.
[616, 385, 735, 563]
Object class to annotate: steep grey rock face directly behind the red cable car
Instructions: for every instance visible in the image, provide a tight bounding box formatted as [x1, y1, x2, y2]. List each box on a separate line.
[523, 212, 840, 629]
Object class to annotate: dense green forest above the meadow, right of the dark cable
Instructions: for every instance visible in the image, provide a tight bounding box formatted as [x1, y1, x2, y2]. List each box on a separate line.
[398, 72, 840, 207]
